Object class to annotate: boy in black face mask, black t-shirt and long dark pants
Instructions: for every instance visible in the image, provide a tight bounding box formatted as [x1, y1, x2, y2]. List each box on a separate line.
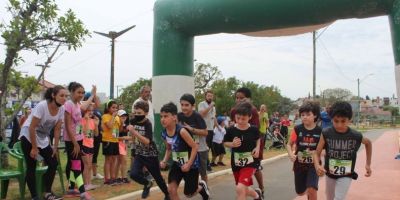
[127, 101, 170, 199]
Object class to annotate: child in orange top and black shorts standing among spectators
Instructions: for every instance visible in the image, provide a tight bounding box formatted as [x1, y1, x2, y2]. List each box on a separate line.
[81, 105, 99, 191]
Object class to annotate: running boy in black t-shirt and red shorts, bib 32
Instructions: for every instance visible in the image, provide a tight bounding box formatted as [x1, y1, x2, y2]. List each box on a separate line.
[224, 102, 262, 200]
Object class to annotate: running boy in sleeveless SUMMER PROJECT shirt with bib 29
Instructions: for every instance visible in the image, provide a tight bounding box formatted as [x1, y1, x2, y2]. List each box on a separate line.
[314, 101, 372, 200]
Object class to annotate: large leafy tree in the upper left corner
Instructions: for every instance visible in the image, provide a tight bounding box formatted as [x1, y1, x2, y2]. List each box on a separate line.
[0, 0, 89, 142]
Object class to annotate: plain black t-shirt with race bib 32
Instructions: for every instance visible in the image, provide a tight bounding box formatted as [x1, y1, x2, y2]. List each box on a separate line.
[224, 126, 260, 171]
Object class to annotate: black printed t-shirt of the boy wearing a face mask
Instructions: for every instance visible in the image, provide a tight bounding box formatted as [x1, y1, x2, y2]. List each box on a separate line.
[132, 119, 158, 157]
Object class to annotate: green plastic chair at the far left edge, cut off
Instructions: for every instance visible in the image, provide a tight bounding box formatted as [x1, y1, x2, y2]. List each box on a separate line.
[0, 142, 25, 199]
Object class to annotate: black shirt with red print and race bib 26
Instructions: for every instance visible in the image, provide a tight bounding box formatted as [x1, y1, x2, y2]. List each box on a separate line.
[293, 124, 322, 170]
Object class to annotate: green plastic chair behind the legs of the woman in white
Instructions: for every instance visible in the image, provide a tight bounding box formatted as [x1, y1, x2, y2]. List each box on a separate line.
[13, 141, 65, 199]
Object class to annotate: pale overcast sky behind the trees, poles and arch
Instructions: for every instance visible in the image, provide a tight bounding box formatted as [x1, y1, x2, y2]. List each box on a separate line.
[0, 0, 395, 99]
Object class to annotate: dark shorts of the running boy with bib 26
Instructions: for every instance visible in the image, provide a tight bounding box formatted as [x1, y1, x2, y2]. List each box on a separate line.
[294, 167, 319, 194]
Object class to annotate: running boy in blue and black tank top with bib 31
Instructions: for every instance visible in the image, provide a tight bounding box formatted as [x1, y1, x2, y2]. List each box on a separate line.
[160, 102, 209, 200]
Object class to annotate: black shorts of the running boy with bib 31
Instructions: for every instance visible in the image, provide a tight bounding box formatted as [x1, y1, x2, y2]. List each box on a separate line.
[168, 162, 199, 196]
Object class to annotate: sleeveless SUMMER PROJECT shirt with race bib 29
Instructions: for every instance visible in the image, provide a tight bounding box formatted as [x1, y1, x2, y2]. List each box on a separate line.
[322, 127, 363, 179]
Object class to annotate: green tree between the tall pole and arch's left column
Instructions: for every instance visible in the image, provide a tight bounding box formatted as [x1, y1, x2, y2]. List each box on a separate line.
[118, 78, 151, 111]
